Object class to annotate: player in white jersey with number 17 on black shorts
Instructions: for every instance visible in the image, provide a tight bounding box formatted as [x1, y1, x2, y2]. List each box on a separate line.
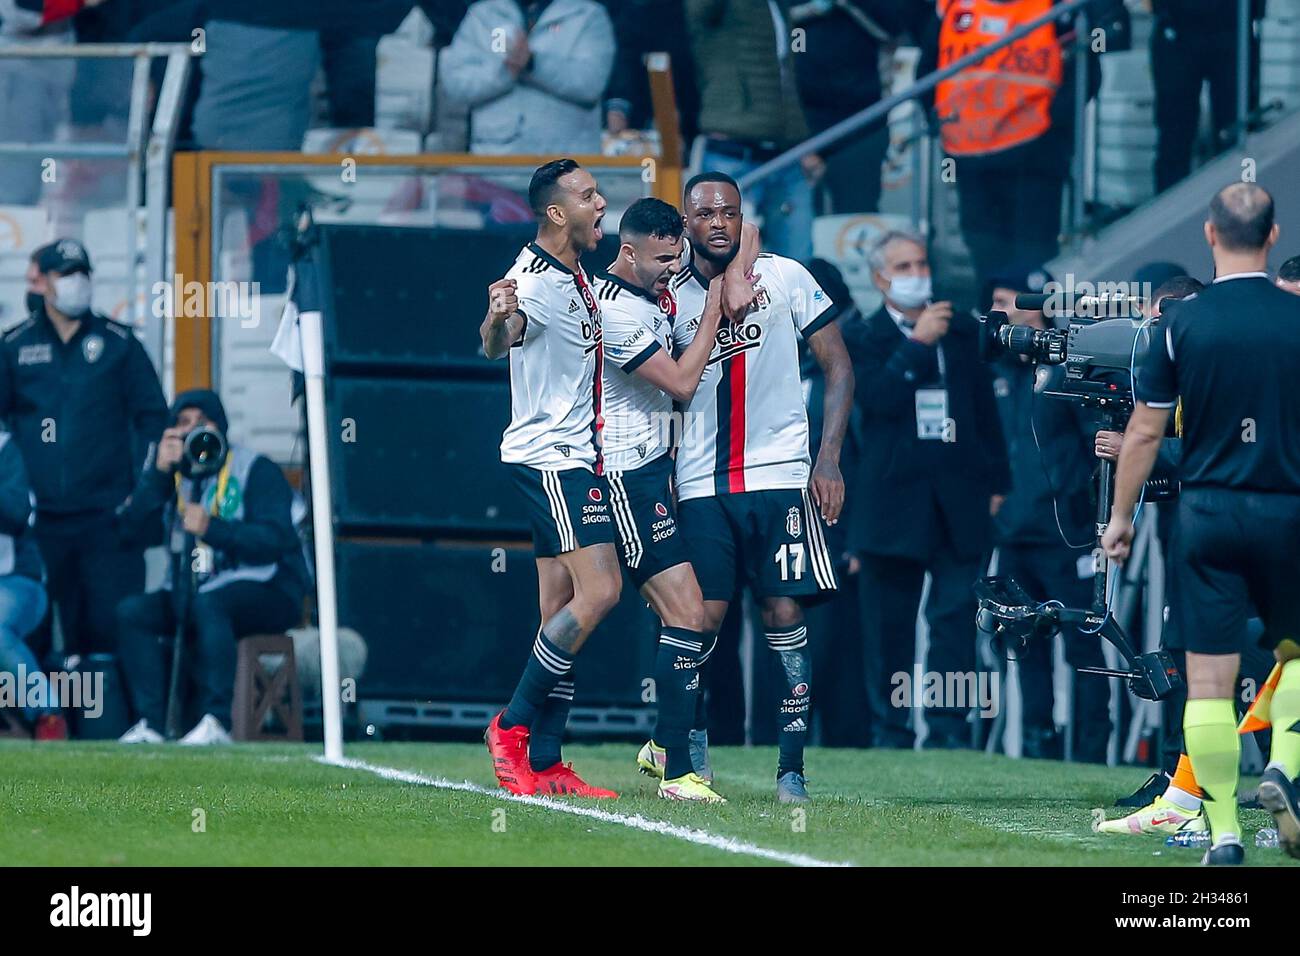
[660, 173, 853, 803]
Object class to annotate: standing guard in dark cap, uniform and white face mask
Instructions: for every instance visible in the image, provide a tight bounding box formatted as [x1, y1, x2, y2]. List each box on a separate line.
[0, 239, 166, 671]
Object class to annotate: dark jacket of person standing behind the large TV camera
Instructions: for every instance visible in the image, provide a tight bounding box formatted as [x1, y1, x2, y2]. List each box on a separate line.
[993, 355, 1097, 550]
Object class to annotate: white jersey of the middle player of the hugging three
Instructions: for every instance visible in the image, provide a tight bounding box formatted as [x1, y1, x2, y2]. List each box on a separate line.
[595, 273, 675, 472]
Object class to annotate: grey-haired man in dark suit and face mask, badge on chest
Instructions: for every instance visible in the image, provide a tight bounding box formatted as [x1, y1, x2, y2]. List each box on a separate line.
[844, 232, 1011, 748]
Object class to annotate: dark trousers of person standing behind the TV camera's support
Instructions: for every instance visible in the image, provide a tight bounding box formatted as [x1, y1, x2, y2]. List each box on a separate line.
[997, 544, 1110, 763]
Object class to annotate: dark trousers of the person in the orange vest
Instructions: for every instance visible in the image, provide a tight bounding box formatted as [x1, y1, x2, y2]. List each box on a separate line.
[957, 160, 1065, 291]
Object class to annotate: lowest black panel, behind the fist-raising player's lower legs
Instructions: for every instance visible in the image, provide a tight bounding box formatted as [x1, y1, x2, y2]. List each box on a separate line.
[338, 541, 657, 708]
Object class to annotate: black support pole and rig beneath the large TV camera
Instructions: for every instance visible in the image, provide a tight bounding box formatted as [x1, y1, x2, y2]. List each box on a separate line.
[975, 395, 1183, 701]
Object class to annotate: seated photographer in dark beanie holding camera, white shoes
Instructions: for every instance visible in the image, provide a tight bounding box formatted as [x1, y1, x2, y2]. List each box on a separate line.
[117, 389, 307, 744]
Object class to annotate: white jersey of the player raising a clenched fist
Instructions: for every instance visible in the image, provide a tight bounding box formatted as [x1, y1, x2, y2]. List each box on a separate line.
[501, 242, 603, 471]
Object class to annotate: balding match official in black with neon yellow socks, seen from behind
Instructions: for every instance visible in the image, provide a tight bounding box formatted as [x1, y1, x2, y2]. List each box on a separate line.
[1102, 182, 1300, 865]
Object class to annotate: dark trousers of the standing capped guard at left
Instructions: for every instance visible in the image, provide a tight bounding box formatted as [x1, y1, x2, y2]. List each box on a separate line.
[33, 511, 144, 657]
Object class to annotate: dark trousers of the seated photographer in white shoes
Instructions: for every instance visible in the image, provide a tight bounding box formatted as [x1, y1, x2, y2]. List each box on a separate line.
[117, 581, 302, 730]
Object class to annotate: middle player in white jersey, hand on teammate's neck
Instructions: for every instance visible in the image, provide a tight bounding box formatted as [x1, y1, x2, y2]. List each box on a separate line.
[595, 198, 758, 803]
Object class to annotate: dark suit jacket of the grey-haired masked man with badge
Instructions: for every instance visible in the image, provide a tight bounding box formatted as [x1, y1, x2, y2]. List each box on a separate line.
[842, 306, 1011, 559]
